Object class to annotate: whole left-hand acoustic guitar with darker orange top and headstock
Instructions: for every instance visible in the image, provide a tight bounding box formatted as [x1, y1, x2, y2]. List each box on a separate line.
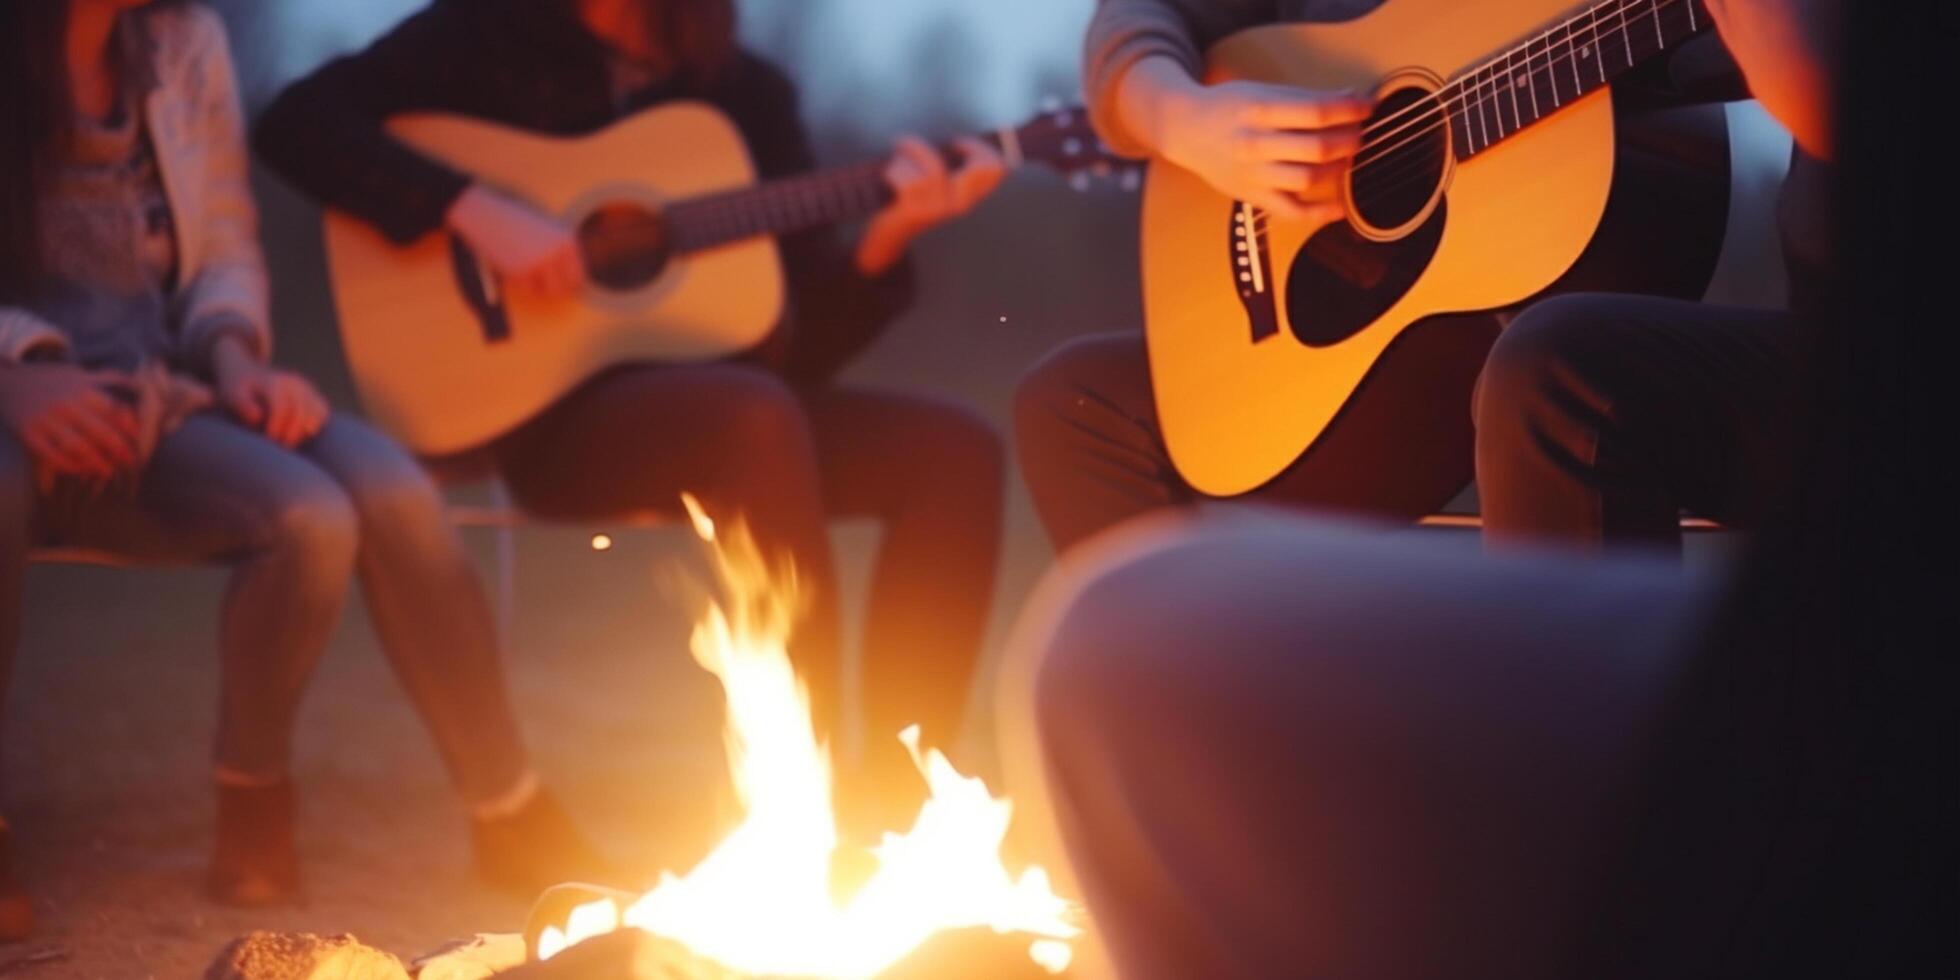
[325, 102, 1125, 455]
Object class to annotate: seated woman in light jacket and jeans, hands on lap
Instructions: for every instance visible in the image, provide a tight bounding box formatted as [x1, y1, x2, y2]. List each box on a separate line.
[0, 0, 596, 935]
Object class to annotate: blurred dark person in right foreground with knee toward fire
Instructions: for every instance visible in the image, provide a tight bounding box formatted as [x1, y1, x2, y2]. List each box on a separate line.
[1035, 0, 1960, 980]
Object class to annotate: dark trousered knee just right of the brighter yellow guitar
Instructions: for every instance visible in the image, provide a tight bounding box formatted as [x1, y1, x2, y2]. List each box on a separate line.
[1476, 296, 1807, 547]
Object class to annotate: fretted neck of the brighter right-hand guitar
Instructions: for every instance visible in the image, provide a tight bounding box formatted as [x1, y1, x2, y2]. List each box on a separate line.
[1437, 0, 1713, 161]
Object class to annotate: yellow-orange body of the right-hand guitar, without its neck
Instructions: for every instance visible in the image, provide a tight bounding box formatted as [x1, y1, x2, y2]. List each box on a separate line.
[1143, 0, 1615, 496]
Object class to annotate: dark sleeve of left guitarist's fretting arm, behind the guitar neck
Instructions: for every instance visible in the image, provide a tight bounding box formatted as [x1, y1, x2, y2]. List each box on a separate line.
[725, 55, 913, 384]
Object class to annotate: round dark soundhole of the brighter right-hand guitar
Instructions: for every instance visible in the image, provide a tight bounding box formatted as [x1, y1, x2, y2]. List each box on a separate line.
[1348, 88, 1450, 239]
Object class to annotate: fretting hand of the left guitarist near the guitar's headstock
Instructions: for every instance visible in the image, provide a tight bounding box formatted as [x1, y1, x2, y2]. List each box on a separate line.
[857, 137, 1007, 276]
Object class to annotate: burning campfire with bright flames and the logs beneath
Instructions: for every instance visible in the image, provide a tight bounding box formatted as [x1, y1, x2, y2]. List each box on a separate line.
[206, 498, 1082, 980]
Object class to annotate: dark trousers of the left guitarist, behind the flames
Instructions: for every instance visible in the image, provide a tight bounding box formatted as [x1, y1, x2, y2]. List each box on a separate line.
[498, 365, 1005, 780]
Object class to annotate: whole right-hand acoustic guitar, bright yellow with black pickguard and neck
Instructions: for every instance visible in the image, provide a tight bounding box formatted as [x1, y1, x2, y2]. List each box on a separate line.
[1143, 0, 1711, 496]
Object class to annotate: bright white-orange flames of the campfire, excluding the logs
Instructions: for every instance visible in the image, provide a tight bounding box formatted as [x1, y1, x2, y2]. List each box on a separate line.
[539, 498, 1080, 978]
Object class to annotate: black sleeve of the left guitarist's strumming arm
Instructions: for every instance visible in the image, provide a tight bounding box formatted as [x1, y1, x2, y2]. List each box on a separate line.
[255, 0, 484, 243]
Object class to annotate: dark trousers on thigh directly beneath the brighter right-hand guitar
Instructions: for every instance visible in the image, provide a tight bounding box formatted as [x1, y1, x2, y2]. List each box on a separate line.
[1013, 316, 1499, 549]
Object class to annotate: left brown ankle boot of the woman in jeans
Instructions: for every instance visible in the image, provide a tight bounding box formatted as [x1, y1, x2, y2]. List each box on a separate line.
[204, 780, 300, 907]
